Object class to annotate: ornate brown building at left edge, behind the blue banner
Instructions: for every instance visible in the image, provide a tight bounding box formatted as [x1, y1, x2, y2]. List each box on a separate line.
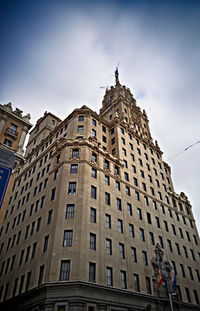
[0, 103, 32, 226]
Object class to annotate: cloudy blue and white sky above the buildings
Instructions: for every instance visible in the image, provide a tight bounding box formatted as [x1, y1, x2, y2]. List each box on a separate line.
[0, 0, 200, 231]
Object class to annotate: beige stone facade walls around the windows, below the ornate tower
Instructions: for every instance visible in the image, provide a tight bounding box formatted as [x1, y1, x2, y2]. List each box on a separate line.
[0, 99, 200, 303]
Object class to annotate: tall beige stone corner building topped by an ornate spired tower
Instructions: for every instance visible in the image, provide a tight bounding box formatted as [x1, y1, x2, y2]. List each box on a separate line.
[0, 70, 200, 311]
